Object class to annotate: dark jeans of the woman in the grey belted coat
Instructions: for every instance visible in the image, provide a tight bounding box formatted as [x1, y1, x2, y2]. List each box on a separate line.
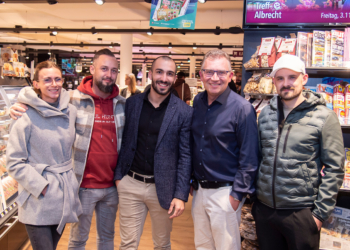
[25, 224, 64, 250]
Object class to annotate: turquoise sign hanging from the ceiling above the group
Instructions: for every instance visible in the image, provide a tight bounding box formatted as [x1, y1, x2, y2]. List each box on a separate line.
[150, 0, 198, 30]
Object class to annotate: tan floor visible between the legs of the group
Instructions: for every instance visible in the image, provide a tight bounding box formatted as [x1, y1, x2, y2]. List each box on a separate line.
[22, 196, 194, 250]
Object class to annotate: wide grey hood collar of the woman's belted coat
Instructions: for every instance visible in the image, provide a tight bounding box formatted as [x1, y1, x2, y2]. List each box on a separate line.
[17, 87, 70, 117]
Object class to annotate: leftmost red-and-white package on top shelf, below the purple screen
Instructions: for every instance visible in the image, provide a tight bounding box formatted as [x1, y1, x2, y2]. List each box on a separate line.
[258, 37, 276, 68]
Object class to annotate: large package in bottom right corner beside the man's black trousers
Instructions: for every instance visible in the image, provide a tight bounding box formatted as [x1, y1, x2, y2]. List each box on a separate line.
[320, 206, 350, 250]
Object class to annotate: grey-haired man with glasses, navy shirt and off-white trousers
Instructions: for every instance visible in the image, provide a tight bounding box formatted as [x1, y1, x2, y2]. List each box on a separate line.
[191, 50, 258, 250]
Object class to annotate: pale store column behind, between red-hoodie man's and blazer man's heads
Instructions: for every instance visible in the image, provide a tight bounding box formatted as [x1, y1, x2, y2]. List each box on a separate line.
[119, 34, 132, 89]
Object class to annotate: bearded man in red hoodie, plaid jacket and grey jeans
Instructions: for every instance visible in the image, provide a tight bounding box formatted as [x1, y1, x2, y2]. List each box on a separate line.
[11, 49, 125, 250]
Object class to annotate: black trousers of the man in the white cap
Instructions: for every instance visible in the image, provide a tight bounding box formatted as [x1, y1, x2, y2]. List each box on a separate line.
[252, 201, 320, 250]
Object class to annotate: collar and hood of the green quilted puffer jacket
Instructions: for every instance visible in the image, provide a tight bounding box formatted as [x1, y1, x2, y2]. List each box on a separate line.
[270, 90, 326, 110]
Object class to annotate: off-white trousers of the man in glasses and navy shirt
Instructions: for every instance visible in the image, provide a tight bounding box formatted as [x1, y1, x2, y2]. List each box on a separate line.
[192, 186, 245, 250]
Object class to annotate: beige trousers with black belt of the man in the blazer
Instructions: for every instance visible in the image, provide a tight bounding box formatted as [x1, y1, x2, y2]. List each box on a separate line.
[118, 175, 173, 250]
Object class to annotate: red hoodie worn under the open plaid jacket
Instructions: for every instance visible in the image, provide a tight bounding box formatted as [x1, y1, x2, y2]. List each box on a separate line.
[78, 76, 119, 188]
